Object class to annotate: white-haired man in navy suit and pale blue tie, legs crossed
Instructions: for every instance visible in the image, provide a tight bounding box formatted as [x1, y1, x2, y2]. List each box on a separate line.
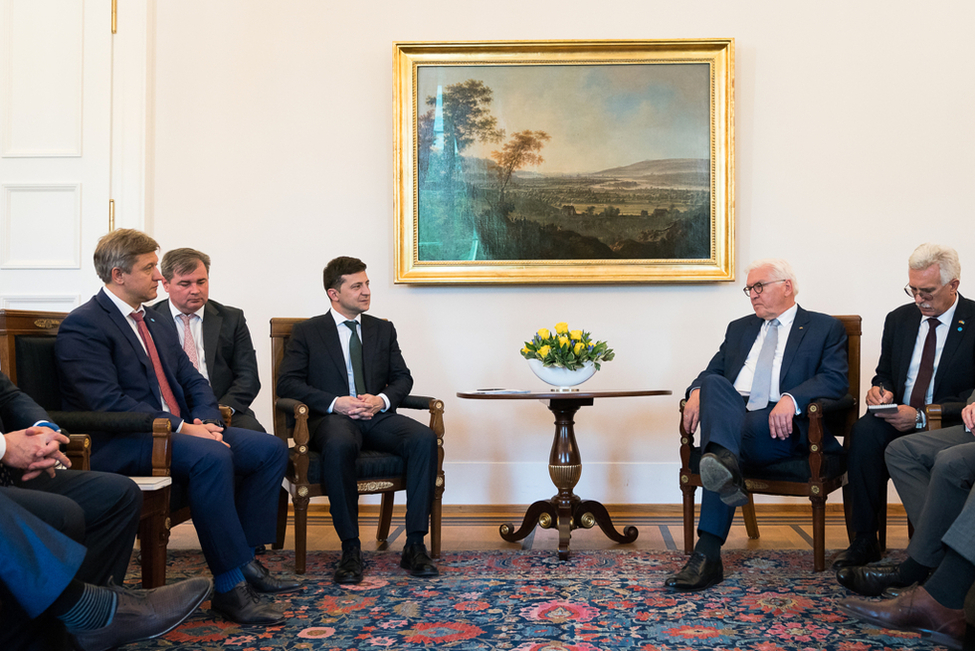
[665, 259, 849, 591]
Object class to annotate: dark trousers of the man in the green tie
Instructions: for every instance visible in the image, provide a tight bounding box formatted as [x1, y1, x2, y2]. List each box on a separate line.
[310, 413, 437, 541]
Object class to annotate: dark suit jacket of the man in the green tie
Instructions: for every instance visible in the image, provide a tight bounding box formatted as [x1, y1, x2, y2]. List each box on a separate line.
[277, 313, 413, 415]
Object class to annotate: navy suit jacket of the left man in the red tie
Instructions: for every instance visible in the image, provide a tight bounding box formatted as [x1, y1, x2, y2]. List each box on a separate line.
[55, 289, 220, 454]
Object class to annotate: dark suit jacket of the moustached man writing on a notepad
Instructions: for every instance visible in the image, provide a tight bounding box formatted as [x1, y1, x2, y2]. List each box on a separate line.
[871, 295, 975, 412]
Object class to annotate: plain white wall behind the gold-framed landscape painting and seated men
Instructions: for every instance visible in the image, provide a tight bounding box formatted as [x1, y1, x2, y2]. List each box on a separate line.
[149, 0, 975, 504]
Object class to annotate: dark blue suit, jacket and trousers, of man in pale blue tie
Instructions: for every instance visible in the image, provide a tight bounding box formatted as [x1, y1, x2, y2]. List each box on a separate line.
[687, 307, 849, 541]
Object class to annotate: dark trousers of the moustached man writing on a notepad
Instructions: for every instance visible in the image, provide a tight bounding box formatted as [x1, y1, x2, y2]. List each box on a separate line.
[845, 412, 905, 534]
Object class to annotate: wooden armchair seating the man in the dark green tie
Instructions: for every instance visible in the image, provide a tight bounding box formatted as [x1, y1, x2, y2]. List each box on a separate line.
[271, 318, 444, 574]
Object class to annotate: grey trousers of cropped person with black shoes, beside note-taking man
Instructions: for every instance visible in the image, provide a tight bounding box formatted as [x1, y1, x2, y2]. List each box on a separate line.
[884, 425, 975, 567]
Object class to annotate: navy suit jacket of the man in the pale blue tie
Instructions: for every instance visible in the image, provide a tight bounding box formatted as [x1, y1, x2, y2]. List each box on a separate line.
[686, 307, 849, 441]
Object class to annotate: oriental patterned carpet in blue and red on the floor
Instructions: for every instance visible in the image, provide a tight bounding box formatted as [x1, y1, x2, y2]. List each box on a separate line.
[126, 551, 952, 651]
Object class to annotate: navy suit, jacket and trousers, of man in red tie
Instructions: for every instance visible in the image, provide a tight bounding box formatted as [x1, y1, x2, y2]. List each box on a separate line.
[55, 289, 287, 574]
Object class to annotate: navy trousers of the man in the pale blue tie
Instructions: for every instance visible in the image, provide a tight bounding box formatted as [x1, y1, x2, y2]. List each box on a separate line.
[698, 375, 799, 543]
